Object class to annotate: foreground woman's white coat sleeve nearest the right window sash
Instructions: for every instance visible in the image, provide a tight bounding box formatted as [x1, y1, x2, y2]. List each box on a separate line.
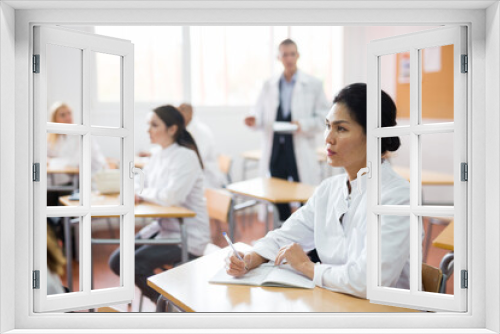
[313, 181, 410, 298]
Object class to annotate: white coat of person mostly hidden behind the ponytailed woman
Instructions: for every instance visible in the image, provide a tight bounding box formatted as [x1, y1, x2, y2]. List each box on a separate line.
[187, 117, 226, 188]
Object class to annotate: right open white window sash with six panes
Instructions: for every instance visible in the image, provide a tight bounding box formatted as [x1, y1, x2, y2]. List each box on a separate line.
[367, 26, 466, 312]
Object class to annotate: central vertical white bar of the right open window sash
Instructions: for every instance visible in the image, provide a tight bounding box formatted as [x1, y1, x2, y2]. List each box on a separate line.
[410, 48, 421, 294]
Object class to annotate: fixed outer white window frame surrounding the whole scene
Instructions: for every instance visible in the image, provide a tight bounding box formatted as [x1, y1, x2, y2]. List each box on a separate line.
[0, 1, 500, 333]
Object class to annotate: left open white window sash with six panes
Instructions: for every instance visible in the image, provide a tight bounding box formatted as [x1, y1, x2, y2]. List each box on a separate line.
[33, 25, 135, 312]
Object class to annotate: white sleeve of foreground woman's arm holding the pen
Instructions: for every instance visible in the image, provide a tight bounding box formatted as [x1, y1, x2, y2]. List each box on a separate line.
[253, 188, 317, 261]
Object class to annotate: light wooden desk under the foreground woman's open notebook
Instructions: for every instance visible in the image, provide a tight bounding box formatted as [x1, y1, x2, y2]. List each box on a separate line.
[148, 243, 416, 312]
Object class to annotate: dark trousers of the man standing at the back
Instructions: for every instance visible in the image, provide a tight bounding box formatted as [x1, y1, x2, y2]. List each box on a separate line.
[270, 140, 299, 221]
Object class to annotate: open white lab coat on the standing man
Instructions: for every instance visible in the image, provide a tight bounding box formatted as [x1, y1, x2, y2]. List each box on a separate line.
[253, 70, 330, 185]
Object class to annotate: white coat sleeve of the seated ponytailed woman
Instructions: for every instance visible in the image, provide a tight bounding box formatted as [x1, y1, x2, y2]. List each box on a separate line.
[139, 150, 201, 206]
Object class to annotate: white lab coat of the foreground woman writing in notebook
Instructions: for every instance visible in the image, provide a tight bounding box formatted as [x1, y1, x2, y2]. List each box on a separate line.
[254, 162, 410, 298]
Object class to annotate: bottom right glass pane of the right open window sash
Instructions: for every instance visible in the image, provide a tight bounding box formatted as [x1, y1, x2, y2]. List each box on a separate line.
[420, 217, 454, 294]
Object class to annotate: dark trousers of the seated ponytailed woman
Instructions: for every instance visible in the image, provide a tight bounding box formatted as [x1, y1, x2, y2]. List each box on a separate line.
[109, 232, 197, 303]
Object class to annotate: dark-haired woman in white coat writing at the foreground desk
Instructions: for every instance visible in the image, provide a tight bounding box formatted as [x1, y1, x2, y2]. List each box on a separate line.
[226, 83, 410, 298]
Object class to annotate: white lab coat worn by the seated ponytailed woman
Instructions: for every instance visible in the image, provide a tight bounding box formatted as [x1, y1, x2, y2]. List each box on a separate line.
[136, 143, 210, 256]
